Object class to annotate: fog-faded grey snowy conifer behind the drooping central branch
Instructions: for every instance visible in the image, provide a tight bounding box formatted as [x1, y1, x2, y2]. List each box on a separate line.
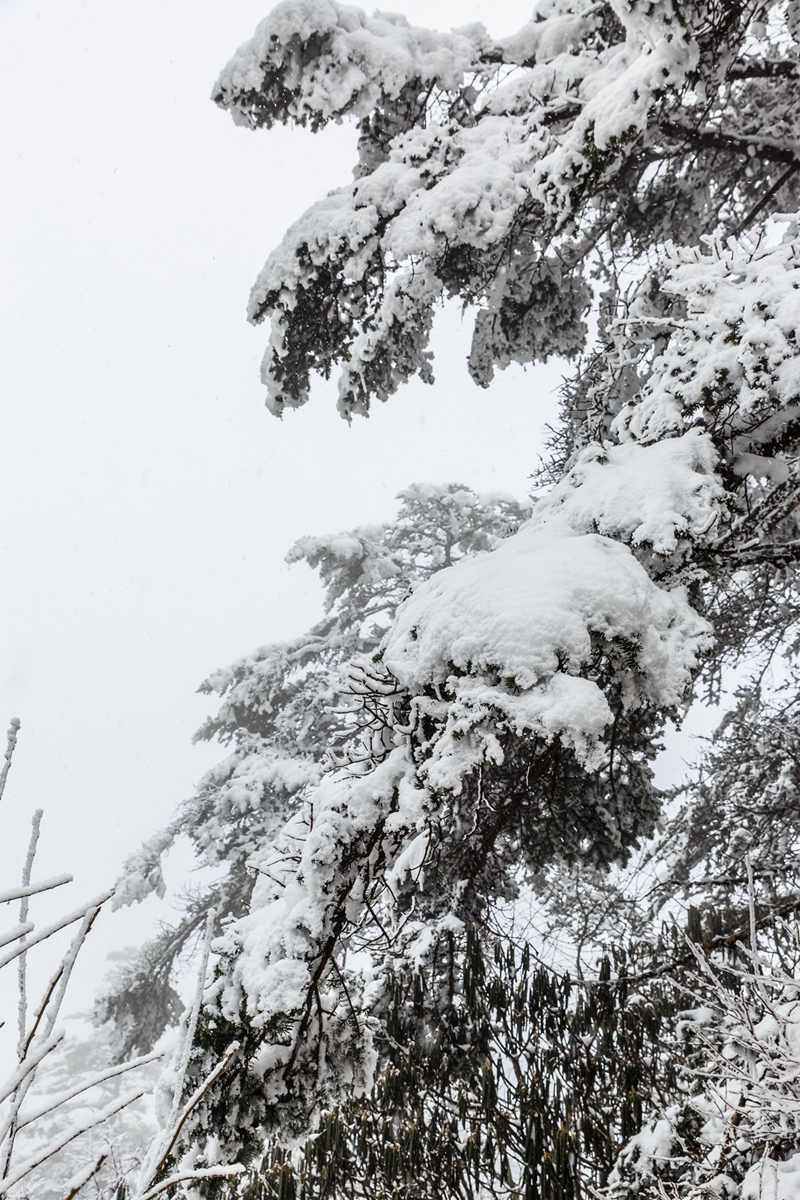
[106, 484, 530, 1055]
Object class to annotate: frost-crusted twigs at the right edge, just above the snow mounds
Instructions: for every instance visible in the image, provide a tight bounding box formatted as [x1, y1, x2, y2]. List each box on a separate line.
[618, 231, 800, 448]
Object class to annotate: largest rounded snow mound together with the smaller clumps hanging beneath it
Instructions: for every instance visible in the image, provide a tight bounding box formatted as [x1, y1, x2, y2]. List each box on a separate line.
[384, 517, 710, 772]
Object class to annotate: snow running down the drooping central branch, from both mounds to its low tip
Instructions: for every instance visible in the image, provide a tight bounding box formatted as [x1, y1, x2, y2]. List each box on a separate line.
[206, 431, 716, 1065]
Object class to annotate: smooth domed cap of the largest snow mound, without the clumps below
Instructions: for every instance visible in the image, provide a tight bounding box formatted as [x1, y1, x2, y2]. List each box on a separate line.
[384, 523, 708, 704]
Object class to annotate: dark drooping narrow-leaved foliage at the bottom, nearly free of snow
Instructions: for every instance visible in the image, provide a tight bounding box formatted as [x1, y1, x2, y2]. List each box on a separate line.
[211, 926, 670, 1200]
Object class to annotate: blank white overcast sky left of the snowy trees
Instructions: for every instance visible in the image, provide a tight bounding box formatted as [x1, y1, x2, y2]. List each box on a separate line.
[0, 0, 558, 1017]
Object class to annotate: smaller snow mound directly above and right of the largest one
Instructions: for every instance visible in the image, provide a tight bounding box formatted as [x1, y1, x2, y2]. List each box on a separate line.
[533, 430, 723, 554]
